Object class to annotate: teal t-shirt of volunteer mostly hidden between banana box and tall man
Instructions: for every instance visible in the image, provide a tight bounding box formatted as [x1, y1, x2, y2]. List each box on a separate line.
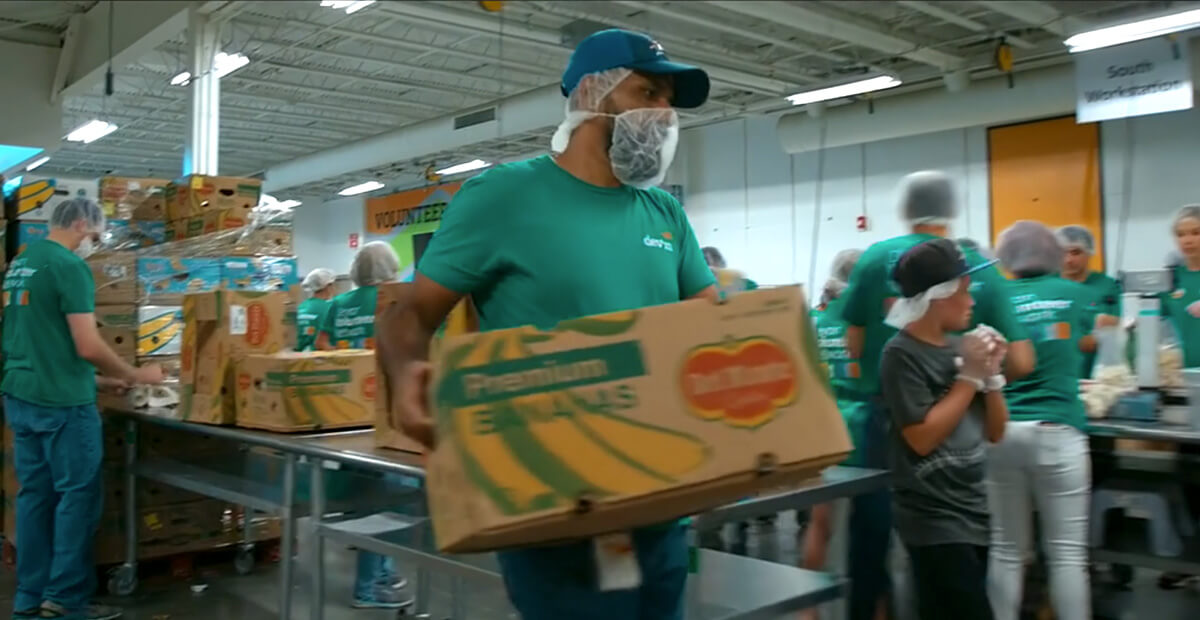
[812, 297, 871, 465]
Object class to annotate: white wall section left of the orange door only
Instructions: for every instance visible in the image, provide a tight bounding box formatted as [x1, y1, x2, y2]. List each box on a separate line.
[674, 118, 988, 292]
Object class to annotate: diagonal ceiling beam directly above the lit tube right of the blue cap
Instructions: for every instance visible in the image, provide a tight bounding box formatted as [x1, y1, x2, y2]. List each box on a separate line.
[708, 0, 966, 71]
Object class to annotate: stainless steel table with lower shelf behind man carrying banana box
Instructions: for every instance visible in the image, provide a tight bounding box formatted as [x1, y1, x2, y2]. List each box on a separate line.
[106, 408, 888, 620]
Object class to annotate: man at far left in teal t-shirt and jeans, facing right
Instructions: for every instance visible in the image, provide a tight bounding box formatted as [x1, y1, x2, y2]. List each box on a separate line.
[0, 198, 163, 620]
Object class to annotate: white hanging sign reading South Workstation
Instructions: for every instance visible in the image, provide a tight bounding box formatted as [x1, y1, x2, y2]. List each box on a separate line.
[1075, 37, 1193, 122]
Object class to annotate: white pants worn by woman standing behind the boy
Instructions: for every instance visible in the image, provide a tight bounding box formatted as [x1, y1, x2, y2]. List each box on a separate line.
[988, 422, 1092, 620]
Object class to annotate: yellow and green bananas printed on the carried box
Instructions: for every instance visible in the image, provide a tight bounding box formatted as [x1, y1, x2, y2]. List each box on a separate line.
[443, 326, 710, 514]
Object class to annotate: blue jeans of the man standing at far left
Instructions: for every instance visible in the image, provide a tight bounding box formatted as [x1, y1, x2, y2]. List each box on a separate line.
[4, 396, 104, 618]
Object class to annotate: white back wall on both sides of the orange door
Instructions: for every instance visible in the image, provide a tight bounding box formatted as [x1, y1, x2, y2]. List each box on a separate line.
[672, 103, 1200, 290]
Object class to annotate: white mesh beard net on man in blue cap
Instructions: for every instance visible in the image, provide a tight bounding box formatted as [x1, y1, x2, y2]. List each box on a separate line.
[608, 108, 679, 189]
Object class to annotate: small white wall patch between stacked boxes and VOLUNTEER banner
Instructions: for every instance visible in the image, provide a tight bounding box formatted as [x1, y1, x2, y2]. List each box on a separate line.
[293, 197, 366, 277]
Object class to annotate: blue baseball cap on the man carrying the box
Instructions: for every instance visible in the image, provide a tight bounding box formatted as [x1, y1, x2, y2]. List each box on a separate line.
[563, 29, 709, 108]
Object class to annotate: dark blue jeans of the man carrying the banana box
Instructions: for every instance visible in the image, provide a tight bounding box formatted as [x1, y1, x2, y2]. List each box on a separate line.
[498, 524, 688, 620]
